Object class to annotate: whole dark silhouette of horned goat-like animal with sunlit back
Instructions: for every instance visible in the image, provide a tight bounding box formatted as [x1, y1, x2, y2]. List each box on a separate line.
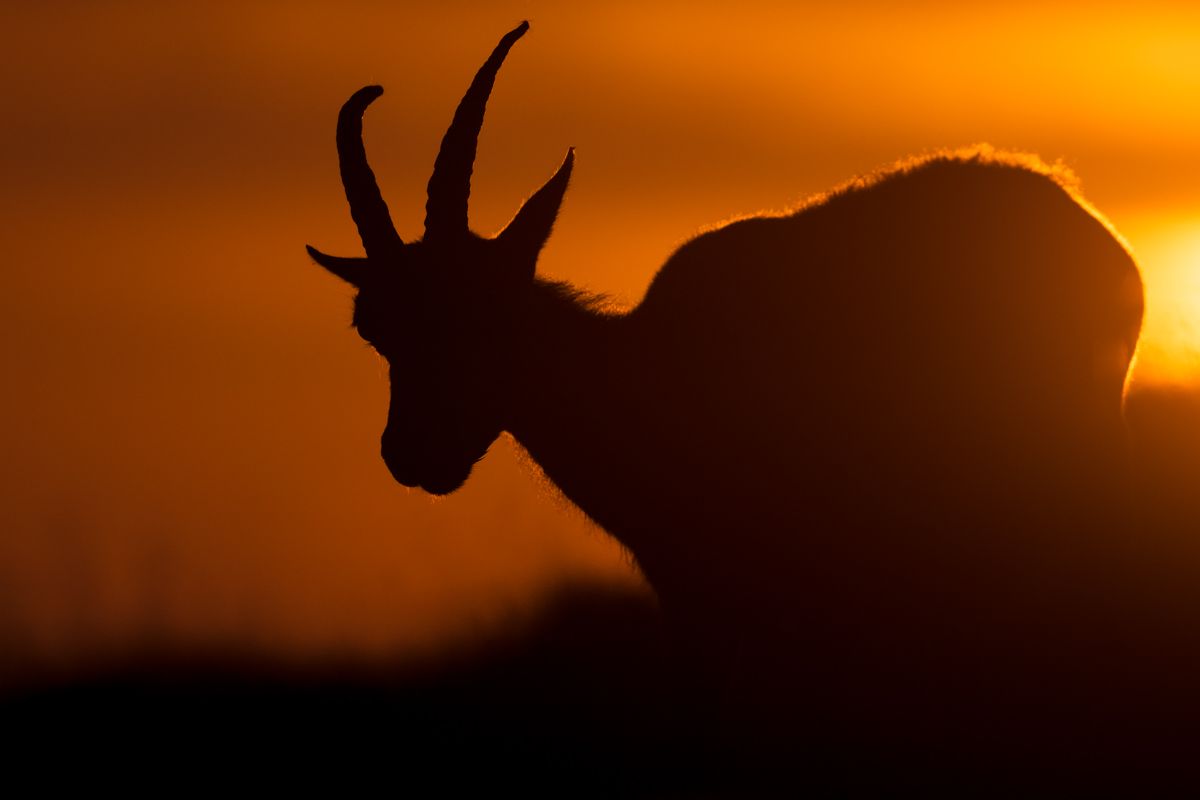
[308, 23, 1196, 780]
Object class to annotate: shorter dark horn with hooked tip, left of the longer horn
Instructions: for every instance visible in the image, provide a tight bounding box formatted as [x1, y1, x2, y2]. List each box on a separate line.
[337, 86, 404, 259]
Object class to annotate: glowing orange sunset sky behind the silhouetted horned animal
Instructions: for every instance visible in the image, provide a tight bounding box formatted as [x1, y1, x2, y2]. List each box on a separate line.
[0, 1, 1200, 686]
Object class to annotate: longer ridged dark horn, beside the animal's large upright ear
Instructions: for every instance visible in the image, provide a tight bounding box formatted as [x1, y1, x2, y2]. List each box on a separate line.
[425, 22, 529, 239]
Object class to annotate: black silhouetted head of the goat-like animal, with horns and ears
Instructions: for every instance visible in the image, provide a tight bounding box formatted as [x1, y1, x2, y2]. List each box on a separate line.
[307, 23, 574, 494]
